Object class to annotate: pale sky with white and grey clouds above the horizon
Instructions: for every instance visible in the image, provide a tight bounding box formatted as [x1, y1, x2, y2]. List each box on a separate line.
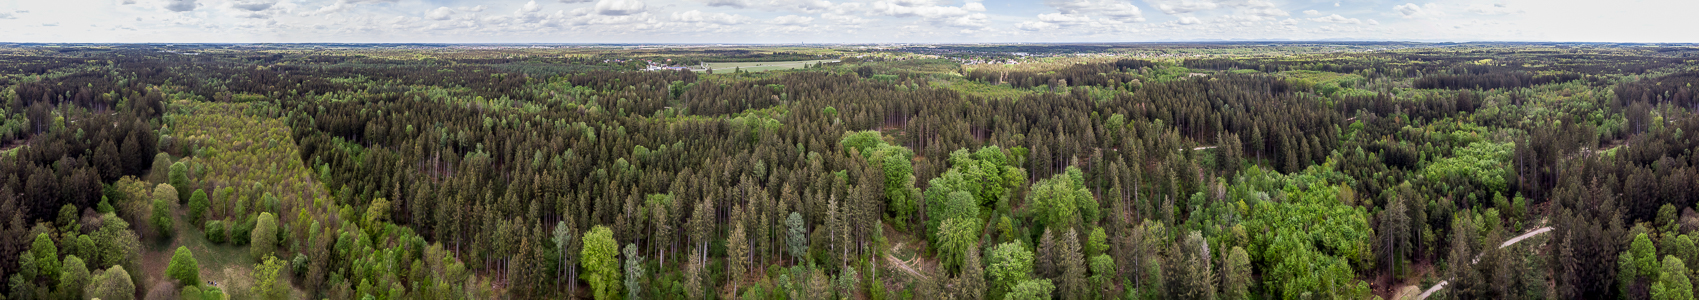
[0, 0, 1699, 42]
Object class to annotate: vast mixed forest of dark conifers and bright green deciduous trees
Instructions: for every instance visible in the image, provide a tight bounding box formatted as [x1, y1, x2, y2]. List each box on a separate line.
[0, 42, 1699, 300]
